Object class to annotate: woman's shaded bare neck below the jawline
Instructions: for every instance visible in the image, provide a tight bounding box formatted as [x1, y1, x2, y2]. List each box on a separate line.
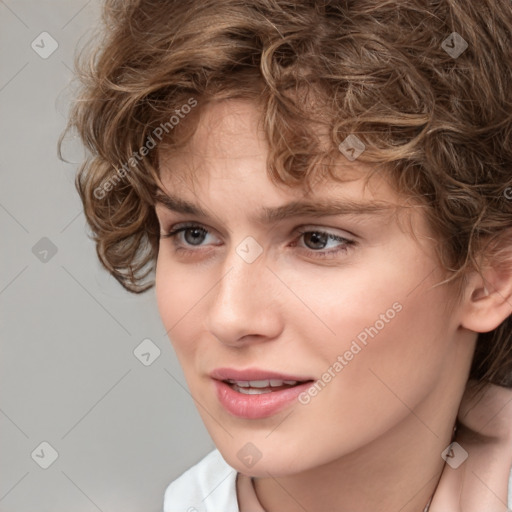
[254, 376, 462, 512]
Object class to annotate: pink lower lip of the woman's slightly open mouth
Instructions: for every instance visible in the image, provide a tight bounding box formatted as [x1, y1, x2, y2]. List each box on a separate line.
[213, 379, 313, 420]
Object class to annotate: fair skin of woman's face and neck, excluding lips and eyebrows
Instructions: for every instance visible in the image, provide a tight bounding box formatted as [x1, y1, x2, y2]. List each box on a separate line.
[155, 100, 510, 512]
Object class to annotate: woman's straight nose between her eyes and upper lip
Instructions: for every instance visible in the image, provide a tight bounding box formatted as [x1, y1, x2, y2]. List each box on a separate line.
[206, 241, 283, 346]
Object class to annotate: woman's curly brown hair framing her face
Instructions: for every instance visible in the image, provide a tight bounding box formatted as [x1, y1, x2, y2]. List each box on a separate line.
[61, 0, 512, 384]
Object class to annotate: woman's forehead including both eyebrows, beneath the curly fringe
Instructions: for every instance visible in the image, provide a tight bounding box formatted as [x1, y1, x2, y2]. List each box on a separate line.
[155, 100, 412, 228]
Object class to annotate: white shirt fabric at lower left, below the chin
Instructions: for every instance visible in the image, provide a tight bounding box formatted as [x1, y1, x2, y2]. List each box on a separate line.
[163, 450, 239, 512]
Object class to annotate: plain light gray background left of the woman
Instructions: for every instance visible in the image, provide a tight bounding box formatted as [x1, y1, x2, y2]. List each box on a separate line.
[0, 0, 214, 512]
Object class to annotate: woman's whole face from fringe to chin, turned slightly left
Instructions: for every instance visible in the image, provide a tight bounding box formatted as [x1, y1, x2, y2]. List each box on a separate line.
[156, 100, 469, 476]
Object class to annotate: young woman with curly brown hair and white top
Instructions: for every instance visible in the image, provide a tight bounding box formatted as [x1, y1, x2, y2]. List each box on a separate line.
[63, 0, 512, 512]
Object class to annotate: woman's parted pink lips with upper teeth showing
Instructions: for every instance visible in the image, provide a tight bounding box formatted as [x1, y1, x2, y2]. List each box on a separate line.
[210, 368, 314, 419]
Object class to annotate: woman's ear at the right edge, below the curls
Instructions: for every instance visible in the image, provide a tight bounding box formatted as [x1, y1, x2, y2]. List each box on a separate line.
[461, 237, 512, 333]
